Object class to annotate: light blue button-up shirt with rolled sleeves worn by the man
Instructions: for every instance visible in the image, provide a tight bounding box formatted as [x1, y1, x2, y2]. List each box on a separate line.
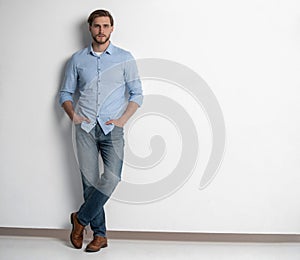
[59, 43, 143, 134]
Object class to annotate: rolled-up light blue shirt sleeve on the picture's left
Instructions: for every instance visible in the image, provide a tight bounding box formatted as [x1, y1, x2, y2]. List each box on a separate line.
[59, 57, 77, 105]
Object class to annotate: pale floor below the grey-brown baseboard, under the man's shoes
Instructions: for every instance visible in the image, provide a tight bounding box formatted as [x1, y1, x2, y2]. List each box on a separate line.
[0, 236, 300, 260]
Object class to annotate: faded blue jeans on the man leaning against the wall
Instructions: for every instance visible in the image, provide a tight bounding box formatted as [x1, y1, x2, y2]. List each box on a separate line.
[75, 124, 124, 237]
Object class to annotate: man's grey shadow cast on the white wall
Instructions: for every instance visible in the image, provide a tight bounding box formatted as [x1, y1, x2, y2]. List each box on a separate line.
[53, 18, 91, 228]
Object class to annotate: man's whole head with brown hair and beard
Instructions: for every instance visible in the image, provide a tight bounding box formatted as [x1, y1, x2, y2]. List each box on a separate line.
[87, 10, 114, 44]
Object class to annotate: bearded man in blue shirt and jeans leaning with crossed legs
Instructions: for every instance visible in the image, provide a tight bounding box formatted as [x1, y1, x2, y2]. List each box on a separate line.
[60, 10, 143, 252]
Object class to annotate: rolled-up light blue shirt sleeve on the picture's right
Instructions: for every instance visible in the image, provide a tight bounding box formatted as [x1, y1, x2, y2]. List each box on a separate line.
[125, 53, 143, 106]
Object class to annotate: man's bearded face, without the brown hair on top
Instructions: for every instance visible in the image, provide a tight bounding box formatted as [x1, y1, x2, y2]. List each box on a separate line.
[90, 16, 114, 44]
